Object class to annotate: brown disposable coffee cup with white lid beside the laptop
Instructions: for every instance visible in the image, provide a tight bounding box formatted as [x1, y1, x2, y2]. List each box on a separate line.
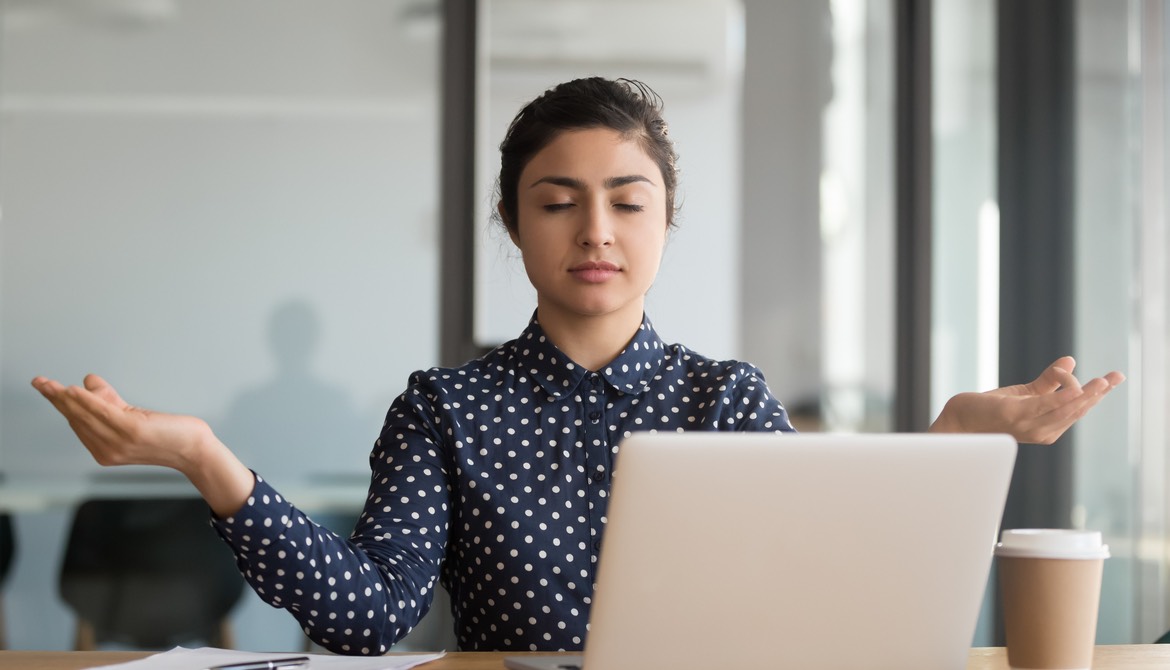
[996, 529, 1109, 670]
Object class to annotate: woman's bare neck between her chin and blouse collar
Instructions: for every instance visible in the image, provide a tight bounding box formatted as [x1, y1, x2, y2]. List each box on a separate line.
[536, 304, 642, 371]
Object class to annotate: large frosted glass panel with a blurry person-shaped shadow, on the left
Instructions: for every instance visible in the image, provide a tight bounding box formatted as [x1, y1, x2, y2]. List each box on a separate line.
[0, 0, 441, 649]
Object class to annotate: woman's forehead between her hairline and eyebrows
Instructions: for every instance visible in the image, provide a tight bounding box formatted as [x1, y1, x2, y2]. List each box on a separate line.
[521, 129, 662, 181]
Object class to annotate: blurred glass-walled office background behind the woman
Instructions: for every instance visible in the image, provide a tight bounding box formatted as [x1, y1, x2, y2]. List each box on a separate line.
[0, 0, 1170, 650]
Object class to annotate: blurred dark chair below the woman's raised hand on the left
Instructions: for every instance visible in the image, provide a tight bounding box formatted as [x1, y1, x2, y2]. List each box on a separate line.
[60, 498, 243, 649]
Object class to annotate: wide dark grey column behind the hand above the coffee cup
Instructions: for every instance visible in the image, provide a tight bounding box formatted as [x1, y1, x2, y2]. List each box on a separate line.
[997, 0, 1076, 527]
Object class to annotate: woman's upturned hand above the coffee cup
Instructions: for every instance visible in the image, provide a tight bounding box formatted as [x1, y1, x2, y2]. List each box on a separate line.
[930, 355, 1126, 444]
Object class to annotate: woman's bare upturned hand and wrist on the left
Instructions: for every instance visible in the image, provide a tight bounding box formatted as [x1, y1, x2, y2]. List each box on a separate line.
[33, 374, 255, 517]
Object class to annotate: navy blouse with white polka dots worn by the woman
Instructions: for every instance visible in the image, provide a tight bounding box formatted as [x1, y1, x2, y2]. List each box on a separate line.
[212, 318, 792, 654]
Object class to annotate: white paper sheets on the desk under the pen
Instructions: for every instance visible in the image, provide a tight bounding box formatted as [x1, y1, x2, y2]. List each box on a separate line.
[87, 647, 443, 670]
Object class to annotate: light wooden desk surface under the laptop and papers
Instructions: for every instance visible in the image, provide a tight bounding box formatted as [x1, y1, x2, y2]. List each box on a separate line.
[0, 644, 1170, 670]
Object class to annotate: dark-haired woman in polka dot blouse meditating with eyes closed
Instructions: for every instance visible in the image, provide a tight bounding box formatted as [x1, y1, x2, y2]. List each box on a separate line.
[33, 78, 1123, 654]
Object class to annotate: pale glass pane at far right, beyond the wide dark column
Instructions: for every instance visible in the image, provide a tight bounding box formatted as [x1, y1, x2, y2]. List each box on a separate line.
[1071, 0, 1170, 643]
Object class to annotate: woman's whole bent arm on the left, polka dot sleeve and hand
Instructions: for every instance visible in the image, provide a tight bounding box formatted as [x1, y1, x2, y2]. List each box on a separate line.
[33, 374, 449, 654]
